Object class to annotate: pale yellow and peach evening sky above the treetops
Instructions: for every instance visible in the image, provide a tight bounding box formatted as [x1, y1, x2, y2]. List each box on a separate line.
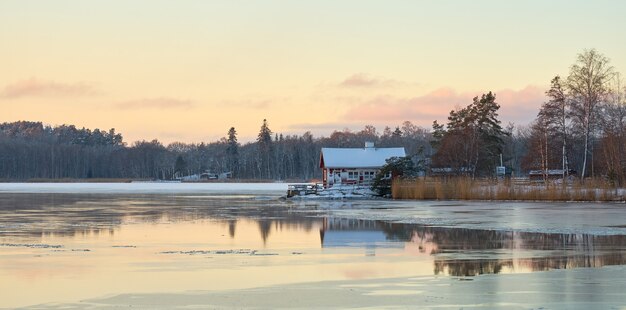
[0, 0, 626, 143]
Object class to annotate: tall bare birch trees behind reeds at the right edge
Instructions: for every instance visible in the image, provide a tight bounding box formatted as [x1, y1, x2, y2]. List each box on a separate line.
[523, 49, 626, 186]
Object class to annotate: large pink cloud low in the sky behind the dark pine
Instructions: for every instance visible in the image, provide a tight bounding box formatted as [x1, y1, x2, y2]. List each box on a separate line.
[344, 86, 545, 126]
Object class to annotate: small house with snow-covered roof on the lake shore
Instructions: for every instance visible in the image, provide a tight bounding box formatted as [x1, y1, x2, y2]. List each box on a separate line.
[320, 142, 406, 188]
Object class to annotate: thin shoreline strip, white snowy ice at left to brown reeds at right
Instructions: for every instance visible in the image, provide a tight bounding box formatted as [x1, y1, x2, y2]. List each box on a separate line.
[0, 179, 626, 204]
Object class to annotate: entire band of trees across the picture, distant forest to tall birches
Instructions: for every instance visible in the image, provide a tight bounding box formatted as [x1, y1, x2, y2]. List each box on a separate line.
[0, 50, 626, 186]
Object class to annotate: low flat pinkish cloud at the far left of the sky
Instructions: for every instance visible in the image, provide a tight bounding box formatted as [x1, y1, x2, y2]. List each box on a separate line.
[0, 78, 98, 99]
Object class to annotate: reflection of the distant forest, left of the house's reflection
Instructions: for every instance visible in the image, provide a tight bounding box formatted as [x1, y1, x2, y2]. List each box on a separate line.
[0, 194, 321, 243]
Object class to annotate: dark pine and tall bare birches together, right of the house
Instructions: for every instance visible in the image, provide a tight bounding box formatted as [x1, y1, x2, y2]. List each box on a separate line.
[432, 49, 626, 186]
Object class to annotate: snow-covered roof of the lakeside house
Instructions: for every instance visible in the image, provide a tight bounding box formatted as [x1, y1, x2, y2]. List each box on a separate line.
[320, 147, 406, 168]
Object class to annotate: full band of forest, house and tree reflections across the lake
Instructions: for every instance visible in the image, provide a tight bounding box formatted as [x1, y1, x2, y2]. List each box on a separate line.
[0, 194, 626, 276]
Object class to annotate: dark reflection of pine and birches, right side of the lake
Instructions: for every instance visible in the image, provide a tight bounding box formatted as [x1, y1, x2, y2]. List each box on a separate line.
[320, 218, 626, 276]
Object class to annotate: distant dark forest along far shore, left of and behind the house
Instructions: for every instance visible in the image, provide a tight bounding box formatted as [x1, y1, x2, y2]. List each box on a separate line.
[0, 120, 430, 181]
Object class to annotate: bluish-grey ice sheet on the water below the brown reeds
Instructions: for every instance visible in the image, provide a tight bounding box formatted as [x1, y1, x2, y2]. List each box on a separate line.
[320, 201, 626, 236]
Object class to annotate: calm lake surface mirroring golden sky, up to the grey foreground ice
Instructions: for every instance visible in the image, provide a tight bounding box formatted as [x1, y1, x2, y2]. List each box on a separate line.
[0, 184, 626, 308]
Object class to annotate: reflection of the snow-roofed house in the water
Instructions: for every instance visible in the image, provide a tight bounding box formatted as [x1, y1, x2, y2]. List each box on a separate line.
[320, 218, 404, 254]
